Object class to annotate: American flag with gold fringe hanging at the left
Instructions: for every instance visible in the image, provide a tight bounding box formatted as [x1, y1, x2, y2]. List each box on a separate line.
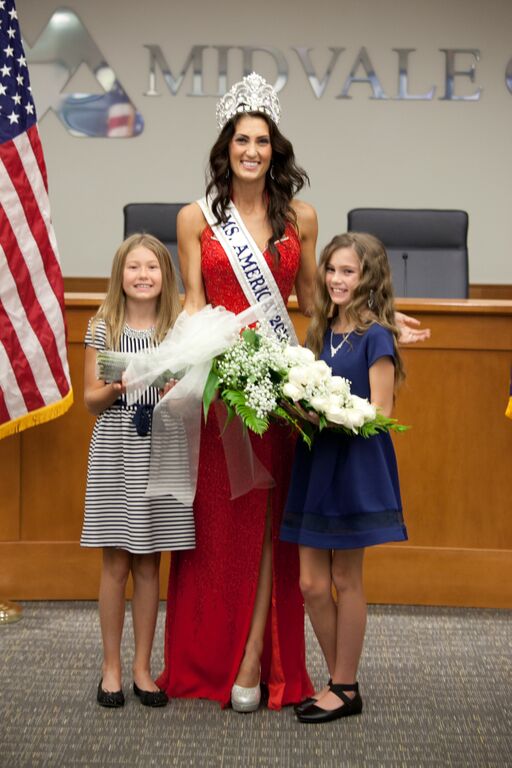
[0, 0, 73, 438]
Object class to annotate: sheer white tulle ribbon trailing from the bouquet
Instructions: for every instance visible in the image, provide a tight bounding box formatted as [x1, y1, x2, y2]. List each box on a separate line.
[123, 305, 274, 505]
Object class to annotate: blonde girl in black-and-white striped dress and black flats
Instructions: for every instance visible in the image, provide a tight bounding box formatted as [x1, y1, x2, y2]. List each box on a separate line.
[81, 234, 195, 707]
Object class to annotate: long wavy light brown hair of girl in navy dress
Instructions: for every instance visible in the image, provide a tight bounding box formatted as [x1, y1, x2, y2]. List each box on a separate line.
[306, 232, 405, 385]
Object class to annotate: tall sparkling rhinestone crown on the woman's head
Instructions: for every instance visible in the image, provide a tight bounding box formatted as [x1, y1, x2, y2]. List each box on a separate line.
[216, 72, 281, 131]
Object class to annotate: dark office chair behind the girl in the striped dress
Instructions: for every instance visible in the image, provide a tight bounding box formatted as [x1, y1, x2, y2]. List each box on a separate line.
[123, 203, 187, 293]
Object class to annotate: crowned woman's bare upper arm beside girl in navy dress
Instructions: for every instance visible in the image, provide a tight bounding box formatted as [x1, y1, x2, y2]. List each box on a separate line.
[292, 200, 318, 316]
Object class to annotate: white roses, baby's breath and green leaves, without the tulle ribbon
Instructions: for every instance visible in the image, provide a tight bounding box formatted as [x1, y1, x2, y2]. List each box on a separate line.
[203, 324, 407, 445]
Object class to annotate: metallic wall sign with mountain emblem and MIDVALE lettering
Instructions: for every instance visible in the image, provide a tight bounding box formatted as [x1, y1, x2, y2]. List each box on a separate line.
[25, 8, 492, 138]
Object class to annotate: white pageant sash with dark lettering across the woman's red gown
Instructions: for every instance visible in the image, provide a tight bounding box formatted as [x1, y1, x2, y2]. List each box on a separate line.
[197, 197, 299, 344]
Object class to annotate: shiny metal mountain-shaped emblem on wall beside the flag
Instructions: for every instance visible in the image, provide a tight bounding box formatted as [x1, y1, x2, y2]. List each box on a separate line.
[24, 8, 144, 138]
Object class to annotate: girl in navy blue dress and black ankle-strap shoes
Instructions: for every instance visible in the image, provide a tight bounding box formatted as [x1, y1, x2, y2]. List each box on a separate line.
[281, 232, 407, 723]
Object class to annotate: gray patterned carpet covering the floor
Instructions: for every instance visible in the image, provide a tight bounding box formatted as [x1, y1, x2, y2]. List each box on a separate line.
[0, 602, 512, 768]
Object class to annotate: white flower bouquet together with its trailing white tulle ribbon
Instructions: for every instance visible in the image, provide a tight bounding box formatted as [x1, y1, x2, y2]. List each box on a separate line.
[93, 305, 406, 504]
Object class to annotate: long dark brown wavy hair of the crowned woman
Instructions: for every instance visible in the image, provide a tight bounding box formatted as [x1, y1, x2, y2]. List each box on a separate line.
[206, 112, 309, 257]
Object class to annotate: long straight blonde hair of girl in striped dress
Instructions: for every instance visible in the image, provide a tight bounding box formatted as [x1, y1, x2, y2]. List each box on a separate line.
[91, 233, 181, 349]
